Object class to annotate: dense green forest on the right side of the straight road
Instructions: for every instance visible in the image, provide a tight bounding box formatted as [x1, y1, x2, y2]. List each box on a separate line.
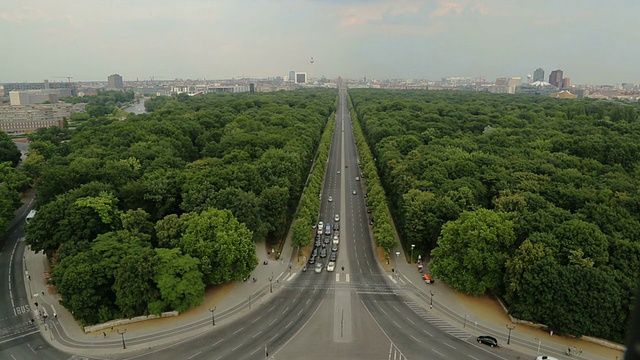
[350, 90, 640, 342]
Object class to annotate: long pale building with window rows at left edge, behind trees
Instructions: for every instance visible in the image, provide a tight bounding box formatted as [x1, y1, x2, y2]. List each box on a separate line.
[0, 103, 86, 134]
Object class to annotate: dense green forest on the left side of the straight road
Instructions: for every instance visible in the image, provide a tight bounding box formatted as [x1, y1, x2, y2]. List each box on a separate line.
[26, 90, 336, 324]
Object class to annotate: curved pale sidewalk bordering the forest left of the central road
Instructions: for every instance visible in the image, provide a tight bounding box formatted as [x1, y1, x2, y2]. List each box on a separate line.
[24, 236, 295, 357]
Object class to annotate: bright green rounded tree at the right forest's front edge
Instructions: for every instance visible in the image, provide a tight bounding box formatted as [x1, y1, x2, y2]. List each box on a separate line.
[429, 209, 515, 296]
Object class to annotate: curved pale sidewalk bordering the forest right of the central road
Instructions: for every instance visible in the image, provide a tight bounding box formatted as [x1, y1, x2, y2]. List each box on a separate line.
[394, 248, 624, 360]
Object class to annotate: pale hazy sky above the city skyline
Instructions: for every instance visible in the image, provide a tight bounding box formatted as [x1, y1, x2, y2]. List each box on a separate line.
[0, 0, 640, 84]
